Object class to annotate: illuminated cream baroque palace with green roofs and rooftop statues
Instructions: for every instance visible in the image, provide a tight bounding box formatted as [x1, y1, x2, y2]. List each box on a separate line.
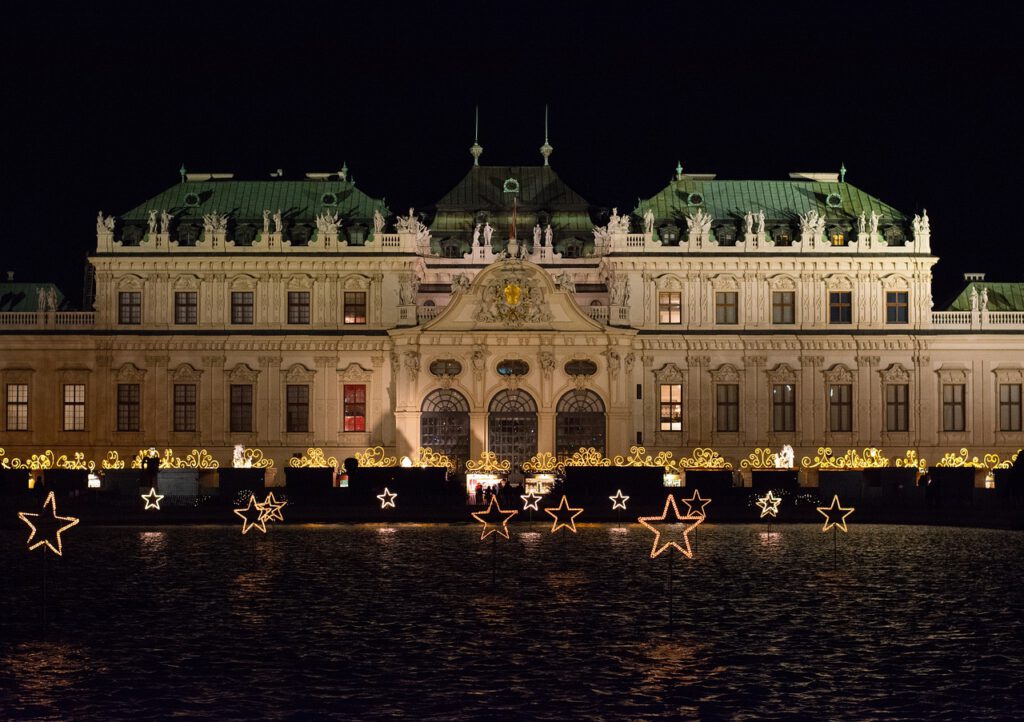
[0, 142, 1024, 476]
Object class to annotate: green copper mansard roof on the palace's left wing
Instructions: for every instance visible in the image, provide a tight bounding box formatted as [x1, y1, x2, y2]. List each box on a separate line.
[121, 180, 388, 222]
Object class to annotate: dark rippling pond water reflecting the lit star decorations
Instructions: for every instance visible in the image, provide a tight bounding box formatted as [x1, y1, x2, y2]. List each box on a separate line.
[0, 522, 1024, 720]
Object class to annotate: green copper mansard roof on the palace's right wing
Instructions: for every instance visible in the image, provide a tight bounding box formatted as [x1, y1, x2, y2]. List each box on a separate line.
[634, 175, 907, 225]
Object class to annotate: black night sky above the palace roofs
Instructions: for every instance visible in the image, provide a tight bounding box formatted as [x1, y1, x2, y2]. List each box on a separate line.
[0, 2, 1024, 301]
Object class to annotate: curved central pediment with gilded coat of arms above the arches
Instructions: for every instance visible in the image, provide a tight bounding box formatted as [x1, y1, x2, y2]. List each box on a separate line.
[423, 260, 604, 331]
